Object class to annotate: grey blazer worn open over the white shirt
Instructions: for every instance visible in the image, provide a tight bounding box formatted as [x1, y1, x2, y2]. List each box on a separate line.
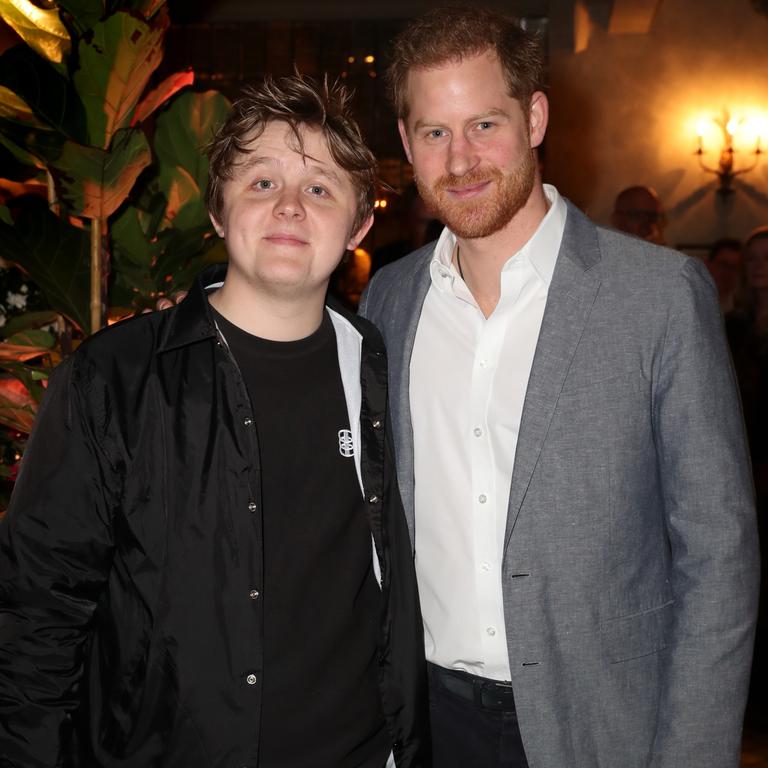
[360, 204, 759, 768]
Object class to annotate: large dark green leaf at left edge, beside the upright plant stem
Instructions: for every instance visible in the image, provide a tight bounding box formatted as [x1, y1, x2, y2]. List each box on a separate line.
[0, 200, 90, 329]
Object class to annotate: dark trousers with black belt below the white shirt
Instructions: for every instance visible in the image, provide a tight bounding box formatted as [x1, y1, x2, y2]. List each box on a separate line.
[428, 664, 528, 768]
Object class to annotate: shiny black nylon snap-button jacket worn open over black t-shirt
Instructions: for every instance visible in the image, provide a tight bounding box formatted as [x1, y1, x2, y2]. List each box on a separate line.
[0, 267, 429, 768]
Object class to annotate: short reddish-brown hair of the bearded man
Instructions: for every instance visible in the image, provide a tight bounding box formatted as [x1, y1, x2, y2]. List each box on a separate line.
[386, 6, 544, 120]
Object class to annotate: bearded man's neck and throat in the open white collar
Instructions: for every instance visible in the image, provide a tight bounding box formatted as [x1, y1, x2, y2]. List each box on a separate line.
[454, 181, 549, 317]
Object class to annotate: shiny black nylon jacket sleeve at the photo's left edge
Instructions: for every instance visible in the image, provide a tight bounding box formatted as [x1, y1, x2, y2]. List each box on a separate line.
[0, 358, 113, 768]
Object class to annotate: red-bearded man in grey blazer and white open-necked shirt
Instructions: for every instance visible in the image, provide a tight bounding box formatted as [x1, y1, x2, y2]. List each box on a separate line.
[360, 8, 758, 768]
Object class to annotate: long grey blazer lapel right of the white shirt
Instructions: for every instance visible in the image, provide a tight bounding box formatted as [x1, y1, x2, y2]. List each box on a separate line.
[504, 203, 600, 555]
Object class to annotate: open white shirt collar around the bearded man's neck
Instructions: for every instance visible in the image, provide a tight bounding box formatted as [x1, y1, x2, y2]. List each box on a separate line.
[430, 184, 568, 290]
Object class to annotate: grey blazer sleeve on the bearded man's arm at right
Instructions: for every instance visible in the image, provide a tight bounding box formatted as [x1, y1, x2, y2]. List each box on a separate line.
[650, 260, 759, 768]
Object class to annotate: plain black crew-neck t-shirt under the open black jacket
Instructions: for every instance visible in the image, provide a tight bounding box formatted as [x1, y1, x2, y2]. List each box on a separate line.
[214, 312, 391, 768]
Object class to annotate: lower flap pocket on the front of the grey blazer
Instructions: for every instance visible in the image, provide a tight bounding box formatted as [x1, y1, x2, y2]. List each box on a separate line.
[602, 600, 675, 663]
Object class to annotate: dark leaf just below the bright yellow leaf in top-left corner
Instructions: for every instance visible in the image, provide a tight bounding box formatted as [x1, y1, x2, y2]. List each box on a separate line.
[0, 45, 87, 142]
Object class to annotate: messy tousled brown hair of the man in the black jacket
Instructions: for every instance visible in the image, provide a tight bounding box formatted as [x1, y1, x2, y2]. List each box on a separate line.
[205, 73, 376, 233]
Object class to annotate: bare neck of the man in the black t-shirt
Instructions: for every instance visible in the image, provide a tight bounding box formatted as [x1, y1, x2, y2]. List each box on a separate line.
[209, 281, 325, 341]
